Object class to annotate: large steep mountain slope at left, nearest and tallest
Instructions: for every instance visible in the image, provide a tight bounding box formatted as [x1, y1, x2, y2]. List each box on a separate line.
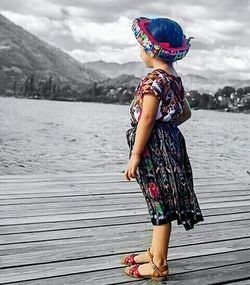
[0, 14, 107, 92]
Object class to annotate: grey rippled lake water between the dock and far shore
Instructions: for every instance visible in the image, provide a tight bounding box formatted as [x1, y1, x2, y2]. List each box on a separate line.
[0, 97, 250, 178]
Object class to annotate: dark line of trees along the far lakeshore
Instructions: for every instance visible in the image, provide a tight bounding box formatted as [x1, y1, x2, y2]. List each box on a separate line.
[5, 74, 250, 109]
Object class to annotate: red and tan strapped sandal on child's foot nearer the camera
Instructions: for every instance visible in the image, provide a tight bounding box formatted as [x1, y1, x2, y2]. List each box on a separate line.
[123, 260, 169, 281]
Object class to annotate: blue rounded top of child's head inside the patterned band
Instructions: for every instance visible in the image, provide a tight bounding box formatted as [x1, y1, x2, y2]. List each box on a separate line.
[147, 18, 183, 47]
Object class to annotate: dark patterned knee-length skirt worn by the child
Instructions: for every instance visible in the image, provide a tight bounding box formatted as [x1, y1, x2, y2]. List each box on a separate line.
[126, 118, 204, 230]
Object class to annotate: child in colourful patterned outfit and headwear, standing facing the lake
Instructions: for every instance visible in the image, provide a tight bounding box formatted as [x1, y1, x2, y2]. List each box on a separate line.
[122, 17, 204, 280]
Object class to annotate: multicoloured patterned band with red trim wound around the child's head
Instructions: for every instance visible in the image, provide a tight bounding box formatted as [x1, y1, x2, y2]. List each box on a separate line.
[132, 17, 193, 61]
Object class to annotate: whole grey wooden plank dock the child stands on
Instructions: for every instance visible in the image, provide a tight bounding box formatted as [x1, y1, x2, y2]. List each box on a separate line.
[0, 173, 250, 285]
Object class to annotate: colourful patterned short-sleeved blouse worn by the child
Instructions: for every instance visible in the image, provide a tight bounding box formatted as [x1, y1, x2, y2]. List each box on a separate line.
[129, 69, 185, 127]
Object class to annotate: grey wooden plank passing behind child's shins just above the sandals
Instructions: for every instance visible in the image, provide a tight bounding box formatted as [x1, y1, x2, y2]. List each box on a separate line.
[0, 232, 250, 271]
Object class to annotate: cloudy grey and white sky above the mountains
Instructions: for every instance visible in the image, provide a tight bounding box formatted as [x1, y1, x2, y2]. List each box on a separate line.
[0, 0, 250, 79]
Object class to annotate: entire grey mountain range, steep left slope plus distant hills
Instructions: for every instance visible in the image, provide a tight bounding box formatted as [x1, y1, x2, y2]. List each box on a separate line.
[0, 14, 250, 92]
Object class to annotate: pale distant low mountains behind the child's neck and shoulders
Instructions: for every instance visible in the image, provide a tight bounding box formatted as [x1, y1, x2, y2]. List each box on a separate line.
[83, 61, 250, 93]
